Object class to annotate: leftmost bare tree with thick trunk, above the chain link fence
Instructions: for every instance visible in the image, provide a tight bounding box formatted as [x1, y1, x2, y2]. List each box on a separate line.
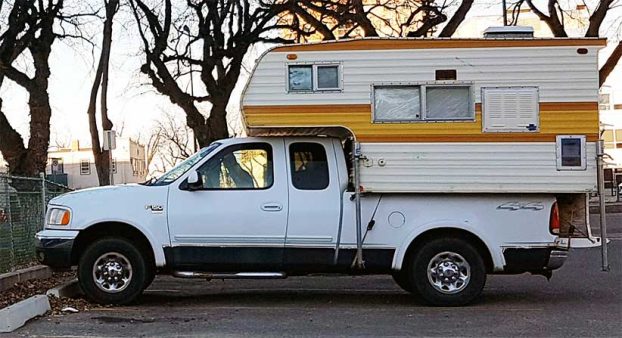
[0, 0, 63, 176]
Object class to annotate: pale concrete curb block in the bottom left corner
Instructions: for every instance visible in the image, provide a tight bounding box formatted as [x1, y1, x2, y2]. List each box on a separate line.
[0, 295, 51, 333]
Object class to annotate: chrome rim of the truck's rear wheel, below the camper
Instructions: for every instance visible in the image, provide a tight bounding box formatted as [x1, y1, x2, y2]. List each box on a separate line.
[427, 251, 471, 294]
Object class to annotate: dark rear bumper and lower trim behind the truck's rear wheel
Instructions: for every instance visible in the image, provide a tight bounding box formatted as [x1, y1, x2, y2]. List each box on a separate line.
[503, 247, 568, 273]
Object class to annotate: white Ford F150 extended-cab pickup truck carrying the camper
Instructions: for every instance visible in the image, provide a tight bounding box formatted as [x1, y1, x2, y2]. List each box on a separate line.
[36, 137, 568, 305]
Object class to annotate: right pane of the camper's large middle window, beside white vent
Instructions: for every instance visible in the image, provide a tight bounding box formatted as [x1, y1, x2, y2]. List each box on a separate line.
[425, 86, 474, 120]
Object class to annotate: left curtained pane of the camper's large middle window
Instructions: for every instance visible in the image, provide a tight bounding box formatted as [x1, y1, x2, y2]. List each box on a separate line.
[374, 86, 421, 122]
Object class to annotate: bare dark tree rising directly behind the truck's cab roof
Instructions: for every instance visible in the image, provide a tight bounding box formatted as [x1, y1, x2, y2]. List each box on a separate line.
[130, 0, 282, 146]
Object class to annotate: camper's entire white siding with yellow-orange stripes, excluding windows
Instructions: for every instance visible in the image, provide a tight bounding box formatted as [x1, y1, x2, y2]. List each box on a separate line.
[242, 39, 604, 193]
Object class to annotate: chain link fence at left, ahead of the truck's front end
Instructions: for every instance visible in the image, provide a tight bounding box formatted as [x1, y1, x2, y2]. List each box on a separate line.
[0, 174, 70, 273]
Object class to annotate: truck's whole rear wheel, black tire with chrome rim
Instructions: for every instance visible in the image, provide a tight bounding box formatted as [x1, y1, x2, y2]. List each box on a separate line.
[410, 238, 486, 306]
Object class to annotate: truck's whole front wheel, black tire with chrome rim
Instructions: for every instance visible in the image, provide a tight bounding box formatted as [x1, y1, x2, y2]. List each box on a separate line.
[78, 238, 149, 304]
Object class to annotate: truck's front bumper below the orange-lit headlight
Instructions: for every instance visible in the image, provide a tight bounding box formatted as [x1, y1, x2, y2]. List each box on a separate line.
[35, 230, 78, 268]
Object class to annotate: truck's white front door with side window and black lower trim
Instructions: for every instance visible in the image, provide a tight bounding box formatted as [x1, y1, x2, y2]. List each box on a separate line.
[166, 138, 288, 272]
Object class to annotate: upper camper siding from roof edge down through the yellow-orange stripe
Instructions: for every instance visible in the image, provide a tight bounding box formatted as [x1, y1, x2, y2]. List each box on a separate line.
[242, 39, 602, 142]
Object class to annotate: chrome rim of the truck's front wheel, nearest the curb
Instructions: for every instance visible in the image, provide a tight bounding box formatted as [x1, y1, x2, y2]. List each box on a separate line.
[93, 252, 132, 293]
